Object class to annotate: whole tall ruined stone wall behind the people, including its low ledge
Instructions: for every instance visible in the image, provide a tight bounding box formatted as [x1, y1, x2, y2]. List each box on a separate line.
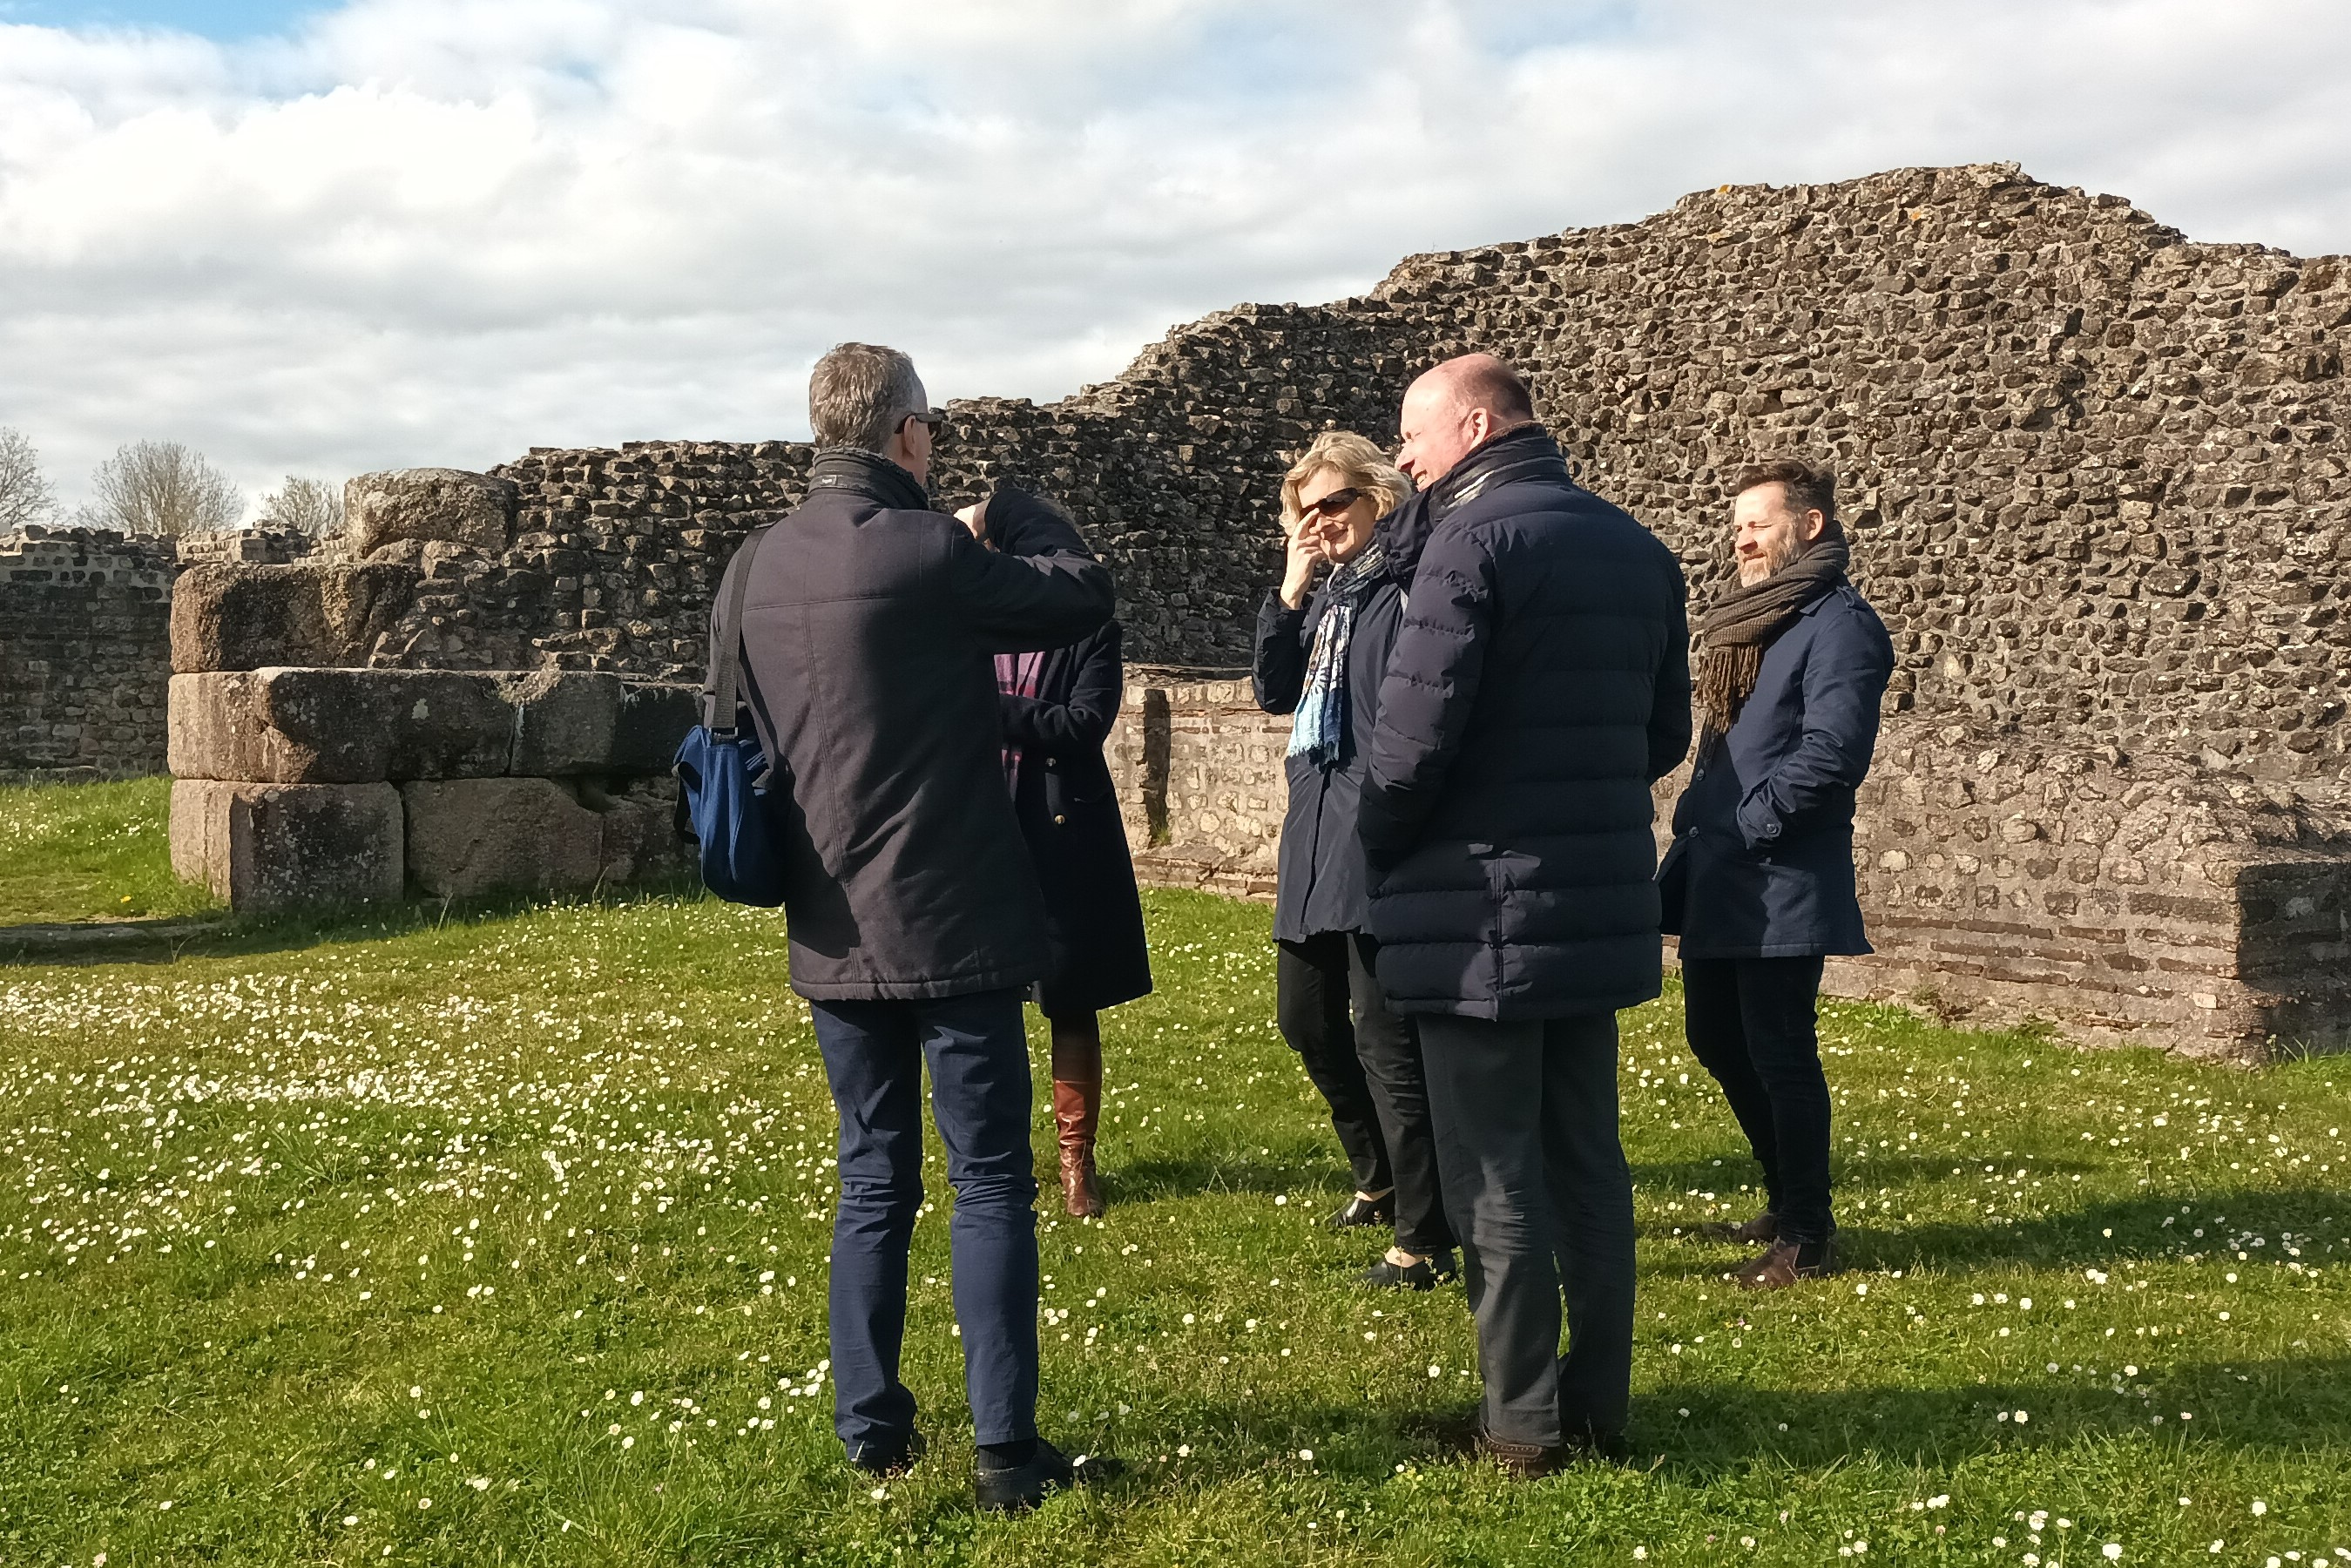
[86, 165, 2351, 1058]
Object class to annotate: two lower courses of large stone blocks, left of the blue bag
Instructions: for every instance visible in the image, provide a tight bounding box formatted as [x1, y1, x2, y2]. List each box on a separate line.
[169, 667, 700, 912]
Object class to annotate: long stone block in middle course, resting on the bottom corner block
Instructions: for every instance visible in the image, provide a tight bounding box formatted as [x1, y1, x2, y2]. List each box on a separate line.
[172, 670, 515, 783]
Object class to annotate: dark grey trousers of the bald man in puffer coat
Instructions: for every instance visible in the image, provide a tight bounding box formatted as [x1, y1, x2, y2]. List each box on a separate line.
[1417, 1013, 1634, 1446]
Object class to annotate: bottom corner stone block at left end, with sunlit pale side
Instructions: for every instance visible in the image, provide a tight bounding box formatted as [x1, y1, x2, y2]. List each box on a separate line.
[172, 778, 402, 915]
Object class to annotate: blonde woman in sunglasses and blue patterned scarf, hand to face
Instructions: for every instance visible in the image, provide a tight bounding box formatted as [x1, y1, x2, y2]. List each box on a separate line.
[1255, 430, 1453, 1291]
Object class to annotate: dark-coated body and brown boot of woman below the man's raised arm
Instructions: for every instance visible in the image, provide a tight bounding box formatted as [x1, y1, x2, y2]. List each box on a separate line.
[996, 620, 1152, 1215]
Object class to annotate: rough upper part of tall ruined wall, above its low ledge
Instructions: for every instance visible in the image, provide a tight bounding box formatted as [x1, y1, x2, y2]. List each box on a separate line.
[331, 167, 2351, 781]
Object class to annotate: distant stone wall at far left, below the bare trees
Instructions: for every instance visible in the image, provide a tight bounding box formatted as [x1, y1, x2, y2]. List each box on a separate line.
[0, 526, 308, 781]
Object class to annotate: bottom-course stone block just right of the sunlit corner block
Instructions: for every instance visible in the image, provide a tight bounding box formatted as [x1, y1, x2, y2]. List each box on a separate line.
[400, 778, 605, 898]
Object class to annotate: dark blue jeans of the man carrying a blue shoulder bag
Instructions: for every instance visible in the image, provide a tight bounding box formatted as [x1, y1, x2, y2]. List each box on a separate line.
[808, 990, 1037, 1457]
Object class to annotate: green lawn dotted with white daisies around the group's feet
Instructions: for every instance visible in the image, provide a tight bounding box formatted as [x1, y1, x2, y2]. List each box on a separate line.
[0, 785, 2351, 1568]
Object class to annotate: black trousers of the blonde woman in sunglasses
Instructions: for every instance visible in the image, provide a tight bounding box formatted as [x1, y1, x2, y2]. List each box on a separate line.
[1274, 931, 1453, 1258]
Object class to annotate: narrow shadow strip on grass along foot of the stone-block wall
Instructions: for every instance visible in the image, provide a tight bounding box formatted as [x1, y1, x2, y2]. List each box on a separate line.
[0, 877, 703, 963]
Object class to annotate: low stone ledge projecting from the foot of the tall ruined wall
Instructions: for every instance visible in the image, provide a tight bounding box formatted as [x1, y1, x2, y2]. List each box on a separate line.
[1110, 667, 2351, 1060]
